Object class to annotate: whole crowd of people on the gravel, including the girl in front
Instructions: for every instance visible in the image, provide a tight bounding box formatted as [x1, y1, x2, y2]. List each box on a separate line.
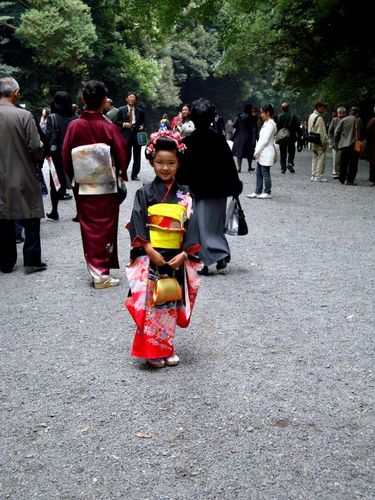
[0, 77, 375, 368]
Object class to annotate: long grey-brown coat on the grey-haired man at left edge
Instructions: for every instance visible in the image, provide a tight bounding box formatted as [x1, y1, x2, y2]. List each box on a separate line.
[0, 100, 44, 219]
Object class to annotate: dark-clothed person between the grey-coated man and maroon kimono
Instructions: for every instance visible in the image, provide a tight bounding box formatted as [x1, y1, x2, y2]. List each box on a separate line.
[46, 91, 77, 220]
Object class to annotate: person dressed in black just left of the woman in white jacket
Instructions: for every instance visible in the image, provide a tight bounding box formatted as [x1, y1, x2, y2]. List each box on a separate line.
[232, 104, 258, 172]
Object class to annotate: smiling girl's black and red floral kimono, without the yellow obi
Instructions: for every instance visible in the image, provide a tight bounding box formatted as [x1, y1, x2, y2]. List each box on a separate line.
[125, 177, 201, 359]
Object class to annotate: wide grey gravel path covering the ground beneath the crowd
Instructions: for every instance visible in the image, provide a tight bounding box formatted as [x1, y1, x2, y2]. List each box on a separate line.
[0, 151, 375, 500]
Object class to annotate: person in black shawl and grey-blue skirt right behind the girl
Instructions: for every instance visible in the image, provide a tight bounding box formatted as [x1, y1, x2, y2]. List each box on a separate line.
[176, 99, 242, 275]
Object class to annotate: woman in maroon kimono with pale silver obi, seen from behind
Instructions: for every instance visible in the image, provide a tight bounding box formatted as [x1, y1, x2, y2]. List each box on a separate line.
[63, 80, 128, 288]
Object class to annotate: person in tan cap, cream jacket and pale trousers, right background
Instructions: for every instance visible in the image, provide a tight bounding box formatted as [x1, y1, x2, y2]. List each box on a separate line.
[307, 100, 328, 182]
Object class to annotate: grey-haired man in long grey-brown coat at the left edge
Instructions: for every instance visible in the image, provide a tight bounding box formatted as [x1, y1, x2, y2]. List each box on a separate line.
[0, 77, 47, 274]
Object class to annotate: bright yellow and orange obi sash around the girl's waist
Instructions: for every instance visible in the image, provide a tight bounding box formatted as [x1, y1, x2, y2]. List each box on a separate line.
[147, 203, 187, 249]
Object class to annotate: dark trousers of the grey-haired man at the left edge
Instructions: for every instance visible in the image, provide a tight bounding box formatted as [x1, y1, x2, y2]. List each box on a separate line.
[0, 219, 41, 273]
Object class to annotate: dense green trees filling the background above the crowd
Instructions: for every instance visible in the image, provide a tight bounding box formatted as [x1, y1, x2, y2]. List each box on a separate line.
[0, 0, 375, 129]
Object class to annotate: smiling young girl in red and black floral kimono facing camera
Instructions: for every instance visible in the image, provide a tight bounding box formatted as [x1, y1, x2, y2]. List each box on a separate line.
[125, 131, 201, 368]
